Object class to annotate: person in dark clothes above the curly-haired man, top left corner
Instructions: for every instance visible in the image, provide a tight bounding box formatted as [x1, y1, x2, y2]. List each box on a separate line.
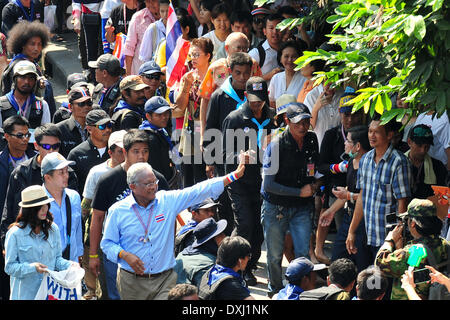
[2, 0, 44, 36]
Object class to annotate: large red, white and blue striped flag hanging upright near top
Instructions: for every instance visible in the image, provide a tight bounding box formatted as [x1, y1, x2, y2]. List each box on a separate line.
[166, 2, 190, 87]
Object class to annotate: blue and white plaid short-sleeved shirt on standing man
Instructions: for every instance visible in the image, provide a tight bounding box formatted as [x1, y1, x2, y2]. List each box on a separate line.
[356, 145, 412, 247]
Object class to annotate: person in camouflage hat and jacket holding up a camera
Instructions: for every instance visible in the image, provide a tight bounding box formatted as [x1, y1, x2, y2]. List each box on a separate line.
[375, 199, 450, 300]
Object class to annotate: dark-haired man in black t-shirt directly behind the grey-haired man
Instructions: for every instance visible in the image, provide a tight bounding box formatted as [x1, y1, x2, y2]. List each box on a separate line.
[89, 129, 169, 299]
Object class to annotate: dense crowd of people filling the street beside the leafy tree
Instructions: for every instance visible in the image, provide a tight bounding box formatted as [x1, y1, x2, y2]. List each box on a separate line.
[0, 0, 450, 300]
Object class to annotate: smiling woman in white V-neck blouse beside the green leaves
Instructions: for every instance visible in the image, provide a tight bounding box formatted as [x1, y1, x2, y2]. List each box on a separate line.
[269, 41, 306, 108]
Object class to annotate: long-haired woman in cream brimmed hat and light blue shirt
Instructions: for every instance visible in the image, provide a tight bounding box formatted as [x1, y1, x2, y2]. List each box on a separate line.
[5, 185, 78, 300]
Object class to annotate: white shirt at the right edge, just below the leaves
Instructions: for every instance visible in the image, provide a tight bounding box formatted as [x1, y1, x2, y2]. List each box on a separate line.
[414, 112, 450, 165]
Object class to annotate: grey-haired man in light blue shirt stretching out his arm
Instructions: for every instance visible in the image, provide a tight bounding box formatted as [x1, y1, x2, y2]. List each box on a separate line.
[100, 152, 249, 300]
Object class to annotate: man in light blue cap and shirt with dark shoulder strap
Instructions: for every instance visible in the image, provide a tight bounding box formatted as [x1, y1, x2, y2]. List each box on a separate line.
[41, 152, 83, 262]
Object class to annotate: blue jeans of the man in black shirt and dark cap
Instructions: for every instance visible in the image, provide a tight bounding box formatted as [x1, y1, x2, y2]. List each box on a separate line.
[261, 200, 314, 293]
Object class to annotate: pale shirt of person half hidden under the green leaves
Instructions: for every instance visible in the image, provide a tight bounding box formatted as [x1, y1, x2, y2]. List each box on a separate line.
[303, 84, 341, 149]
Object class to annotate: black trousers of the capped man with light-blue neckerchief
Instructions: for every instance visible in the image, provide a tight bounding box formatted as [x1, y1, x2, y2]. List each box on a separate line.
[228, 182, 264, 271]
